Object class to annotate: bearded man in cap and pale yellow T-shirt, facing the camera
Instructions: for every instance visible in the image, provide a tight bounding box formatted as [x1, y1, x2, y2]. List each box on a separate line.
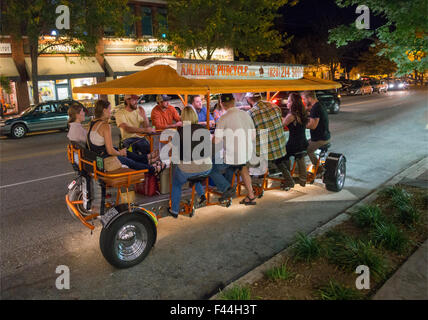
[115, 94, 154, 155]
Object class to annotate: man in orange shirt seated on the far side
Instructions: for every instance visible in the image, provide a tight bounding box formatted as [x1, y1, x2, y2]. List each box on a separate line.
[151, 94, 182, 130]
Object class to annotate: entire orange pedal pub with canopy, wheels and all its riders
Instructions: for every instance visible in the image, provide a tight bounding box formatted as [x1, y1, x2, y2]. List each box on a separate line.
[66, 58, 346, 268]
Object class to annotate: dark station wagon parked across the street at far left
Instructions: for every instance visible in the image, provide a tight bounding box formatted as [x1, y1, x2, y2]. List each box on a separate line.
[0, 100, 89, 139]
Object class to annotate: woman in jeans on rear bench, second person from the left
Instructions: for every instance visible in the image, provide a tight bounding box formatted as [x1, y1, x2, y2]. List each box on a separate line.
[87, 100, 166, 175]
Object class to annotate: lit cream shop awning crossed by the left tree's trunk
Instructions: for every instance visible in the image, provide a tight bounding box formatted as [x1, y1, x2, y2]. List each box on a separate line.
[25, 57, 105, 80]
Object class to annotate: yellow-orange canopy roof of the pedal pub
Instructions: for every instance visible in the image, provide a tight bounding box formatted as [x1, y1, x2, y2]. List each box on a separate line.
[73, 65, 341, 94]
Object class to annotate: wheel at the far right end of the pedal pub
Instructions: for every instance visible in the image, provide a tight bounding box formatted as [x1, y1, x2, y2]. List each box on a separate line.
[323, 153, 346, 192]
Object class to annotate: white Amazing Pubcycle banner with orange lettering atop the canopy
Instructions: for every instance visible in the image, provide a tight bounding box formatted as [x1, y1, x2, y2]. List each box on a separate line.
[177, 61, 303, 80]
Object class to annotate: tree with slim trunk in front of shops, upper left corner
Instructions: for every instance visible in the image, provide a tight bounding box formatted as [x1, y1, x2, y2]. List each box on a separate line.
[1, 0, 129, 103]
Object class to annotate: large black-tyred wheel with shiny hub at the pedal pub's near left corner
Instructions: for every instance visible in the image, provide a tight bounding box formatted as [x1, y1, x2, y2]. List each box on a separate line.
[100, 212, 155, 269]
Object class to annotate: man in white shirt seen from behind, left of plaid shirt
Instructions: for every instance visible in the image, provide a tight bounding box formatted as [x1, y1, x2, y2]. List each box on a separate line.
[210, 94, 256, 205]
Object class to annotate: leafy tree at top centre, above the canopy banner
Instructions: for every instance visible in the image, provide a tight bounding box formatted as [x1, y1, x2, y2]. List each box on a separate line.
[161, 0, 296, 60]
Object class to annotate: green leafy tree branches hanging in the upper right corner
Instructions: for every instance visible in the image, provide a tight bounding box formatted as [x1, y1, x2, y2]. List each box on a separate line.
[329, 0, 428, 75]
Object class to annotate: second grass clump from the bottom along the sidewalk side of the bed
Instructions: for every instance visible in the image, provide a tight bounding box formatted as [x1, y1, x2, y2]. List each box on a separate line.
[326, 237, 388, 279]
